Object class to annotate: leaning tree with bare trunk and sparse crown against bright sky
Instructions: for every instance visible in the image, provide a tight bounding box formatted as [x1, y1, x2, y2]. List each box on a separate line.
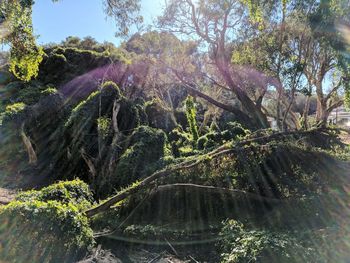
[158, 0, 269, 128]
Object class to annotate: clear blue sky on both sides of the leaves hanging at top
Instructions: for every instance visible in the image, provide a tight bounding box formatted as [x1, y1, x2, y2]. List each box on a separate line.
[33, 0, 164, 45]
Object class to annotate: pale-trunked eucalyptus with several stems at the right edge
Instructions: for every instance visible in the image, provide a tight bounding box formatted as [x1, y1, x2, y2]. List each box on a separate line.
[245, 0, 350, 126]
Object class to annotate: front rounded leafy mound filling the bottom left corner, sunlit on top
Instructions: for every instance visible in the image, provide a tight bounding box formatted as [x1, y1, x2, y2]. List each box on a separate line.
[0, 201, 94, 262]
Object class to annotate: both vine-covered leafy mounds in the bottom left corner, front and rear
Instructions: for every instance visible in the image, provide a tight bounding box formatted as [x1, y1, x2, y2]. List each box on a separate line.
[0, 180, 94, 262]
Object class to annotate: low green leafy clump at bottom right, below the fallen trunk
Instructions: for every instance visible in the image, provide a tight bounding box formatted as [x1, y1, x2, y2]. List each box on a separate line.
[220, 220, 317, 263]
